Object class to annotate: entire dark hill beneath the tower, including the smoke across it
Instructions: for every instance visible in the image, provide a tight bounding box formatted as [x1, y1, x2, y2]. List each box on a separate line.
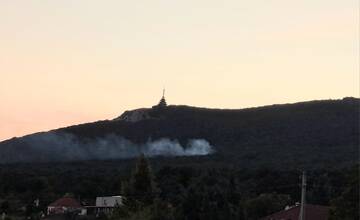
[0, 98, 360, 168]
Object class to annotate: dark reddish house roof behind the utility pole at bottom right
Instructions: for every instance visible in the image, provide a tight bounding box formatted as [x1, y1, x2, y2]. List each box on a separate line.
[262, 204, 329, 220]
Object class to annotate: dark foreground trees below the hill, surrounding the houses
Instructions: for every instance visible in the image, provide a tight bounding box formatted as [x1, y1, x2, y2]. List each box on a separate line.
[0, 157, 359, 220]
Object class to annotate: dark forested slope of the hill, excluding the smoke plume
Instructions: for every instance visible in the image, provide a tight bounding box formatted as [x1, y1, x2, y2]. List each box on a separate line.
[0, 98, 360, 167]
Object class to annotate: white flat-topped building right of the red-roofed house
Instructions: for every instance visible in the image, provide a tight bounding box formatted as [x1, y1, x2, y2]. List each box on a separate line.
[86, 196, 124, 215]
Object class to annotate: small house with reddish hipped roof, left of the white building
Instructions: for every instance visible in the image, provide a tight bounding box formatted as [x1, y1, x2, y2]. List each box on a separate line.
[47, 194, 84, 215]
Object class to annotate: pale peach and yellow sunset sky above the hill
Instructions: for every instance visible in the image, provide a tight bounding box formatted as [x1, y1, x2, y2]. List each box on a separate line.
[0, 0, 359, 140]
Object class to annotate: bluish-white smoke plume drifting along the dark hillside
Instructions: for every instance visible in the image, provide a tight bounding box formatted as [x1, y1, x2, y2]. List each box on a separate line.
[0, 132, 214, 163]
